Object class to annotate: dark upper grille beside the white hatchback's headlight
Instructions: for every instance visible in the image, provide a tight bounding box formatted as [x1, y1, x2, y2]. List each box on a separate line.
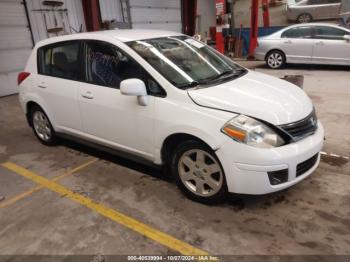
[279, 110, 317, 141]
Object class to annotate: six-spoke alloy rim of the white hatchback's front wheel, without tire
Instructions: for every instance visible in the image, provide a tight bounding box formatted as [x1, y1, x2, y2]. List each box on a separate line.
[178, 149, 224, 197]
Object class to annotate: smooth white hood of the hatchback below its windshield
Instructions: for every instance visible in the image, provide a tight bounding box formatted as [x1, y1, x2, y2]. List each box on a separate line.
[188, 71, 313, 125]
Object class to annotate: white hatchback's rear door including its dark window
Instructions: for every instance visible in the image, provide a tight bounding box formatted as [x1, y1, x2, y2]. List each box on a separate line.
[35, 41, 81, 132]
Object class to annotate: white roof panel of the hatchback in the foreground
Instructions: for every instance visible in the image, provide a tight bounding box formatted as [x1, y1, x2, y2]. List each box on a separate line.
[37, 29, 183, 46]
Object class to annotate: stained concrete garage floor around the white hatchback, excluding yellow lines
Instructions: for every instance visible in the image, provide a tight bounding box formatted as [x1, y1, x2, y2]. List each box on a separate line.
[0, 61, 350, 255]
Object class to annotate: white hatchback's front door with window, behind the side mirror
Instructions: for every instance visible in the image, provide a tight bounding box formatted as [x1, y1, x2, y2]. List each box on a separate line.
[78, 41, 156, 159]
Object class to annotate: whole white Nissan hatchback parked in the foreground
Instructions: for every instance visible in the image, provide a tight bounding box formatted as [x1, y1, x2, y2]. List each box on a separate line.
[18, 30, 324, 203]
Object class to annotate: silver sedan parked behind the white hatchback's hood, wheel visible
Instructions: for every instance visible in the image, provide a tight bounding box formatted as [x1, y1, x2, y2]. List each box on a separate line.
[255, 23, 350, 69]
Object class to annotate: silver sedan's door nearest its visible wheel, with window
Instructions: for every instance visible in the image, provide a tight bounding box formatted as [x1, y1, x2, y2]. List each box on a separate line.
[281, 25, 315, 63]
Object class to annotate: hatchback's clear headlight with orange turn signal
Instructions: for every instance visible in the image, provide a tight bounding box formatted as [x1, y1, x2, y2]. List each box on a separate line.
[221, 115, 285, 148]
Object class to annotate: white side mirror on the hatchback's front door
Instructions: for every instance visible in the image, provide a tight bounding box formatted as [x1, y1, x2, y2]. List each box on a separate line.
[120, 78, 148, 106]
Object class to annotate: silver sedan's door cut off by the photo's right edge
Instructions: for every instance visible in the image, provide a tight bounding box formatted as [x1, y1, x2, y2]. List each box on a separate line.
[313, 26, 350, 64]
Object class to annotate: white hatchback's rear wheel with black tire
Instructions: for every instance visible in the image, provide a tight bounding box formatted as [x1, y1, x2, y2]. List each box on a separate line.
[30, 106, 57, 146]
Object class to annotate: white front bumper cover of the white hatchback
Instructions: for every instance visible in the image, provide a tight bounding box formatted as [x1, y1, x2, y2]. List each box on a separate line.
[216, 122, 324, 195]
